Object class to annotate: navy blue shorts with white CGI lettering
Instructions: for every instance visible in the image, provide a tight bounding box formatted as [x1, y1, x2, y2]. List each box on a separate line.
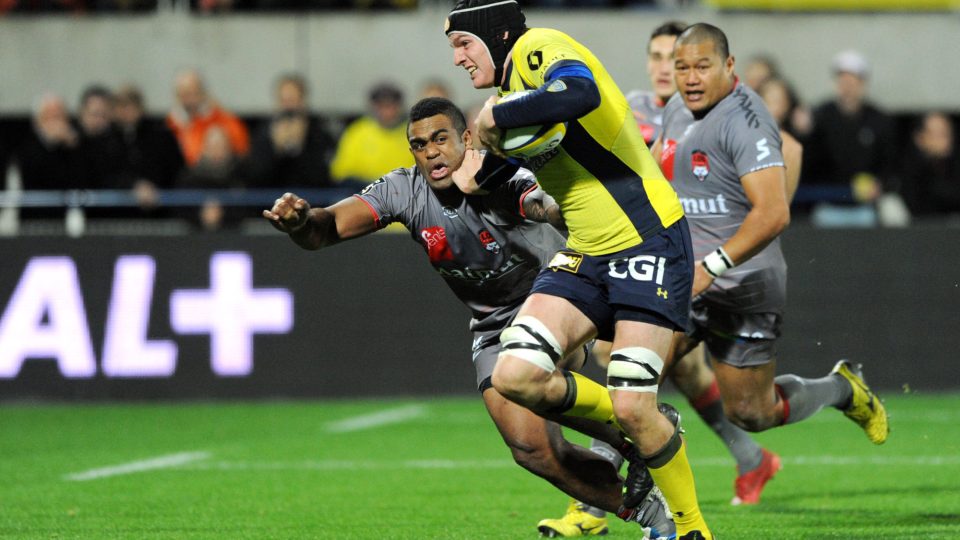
[531, 218, 694, 341]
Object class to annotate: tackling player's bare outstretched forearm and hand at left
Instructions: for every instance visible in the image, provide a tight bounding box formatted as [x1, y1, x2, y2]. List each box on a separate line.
[263, 193, 377, 250]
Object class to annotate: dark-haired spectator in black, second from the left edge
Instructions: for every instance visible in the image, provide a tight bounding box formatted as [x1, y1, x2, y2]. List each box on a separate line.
[77, 84, 123, 192]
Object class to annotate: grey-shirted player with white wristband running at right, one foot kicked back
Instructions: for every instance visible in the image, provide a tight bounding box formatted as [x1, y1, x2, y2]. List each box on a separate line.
[655, 23, 888, 452]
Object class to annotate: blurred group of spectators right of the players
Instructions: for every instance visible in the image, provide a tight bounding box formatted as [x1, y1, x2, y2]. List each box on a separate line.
[752, 50, 960, 226]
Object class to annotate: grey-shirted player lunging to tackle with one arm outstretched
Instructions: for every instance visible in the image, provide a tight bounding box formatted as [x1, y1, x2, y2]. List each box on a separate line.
[263, 98, 669, 536]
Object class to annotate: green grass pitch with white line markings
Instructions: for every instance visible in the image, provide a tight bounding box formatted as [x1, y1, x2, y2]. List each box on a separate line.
[0, 394, 960, 540]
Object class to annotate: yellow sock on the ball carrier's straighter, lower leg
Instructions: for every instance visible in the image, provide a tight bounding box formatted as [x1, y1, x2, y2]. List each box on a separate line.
[647, 441, 713, 540]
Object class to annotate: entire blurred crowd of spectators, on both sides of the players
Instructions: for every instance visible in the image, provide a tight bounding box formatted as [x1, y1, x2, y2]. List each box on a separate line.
[0, 47, 960, 230]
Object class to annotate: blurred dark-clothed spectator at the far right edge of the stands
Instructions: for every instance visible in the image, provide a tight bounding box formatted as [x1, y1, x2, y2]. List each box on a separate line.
[900, 112, 960, 216]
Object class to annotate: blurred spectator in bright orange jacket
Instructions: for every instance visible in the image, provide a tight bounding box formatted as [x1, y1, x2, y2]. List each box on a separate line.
[167, 69, 250, 166]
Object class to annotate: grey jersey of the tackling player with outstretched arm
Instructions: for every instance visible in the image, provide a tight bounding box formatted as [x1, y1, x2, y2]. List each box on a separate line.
[356, 167, 564, 331]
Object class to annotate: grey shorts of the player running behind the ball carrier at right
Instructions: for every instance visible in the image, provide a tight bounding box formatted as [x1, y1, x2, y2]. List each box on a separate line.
[687, 301, 782, 367]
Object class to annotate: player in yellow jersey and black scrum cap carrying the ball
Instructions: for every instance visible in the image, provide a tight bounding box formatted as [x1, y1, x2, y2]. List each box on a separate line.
[445, 0, 713, 540]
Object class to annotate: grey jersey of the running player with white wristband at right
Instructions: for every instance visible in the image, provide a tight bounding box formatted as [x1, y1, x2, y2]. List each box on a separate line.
[660, 82, 787, 314]
